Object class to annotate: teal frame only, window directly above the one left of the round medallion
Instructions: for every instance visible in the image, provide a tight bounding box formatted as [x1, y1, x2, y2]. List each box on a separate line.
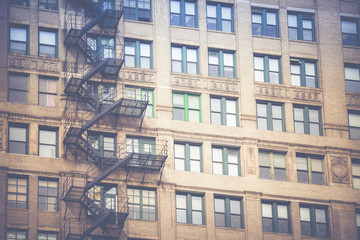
[293, 104, 323, 136]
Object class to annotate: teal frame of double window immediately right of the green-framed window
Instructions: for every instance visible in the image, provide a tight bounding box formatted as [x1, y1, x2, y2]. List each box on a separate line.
[210, 95, 239, 127]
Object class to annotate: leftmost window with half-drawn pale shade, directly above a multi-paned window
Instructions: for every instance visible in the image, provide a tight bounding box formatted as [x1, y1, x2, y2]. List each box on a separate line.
[8, 123, 29, 154]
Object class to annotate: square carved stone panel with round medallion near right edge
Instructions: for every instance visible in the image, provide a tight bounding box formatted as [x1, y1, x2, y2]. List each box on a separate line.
[330, 156, 350, 184]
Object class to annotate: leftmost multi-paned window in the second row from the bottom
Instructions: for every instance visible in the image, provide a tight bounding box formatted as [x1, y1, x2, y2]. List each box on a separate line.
[7, 176, 28, 209]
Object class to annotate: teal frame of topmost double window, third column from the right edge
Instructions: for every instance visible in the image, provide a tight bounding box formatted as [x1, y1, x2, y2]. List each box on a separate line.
[251, 7, 280, 38]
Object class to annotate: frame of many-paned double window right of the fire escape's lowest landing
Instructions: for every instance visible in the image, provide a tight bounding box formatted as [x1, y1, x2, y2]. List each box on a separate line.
[126, 186, 158, 222]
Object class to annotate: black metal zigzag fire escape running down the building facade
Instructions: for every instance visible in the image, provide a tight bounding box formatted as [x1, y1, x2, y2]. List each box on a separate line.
[60, 0, 167, 240]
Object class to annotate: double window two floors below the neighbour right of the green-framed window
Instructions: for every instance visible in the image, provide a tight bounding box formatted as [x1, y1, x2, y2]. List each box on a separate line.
[214, 196, 243, 229]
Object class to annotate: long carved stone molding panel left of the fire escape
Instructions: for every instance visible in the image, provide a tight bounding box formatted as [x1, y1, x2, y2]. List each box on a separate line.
[8, 55, 61, 74]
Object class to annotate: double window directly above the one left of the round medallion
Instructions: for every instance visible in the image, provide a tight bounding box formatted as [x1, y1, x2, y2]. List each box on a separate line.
[294, 105, 322, 136]
